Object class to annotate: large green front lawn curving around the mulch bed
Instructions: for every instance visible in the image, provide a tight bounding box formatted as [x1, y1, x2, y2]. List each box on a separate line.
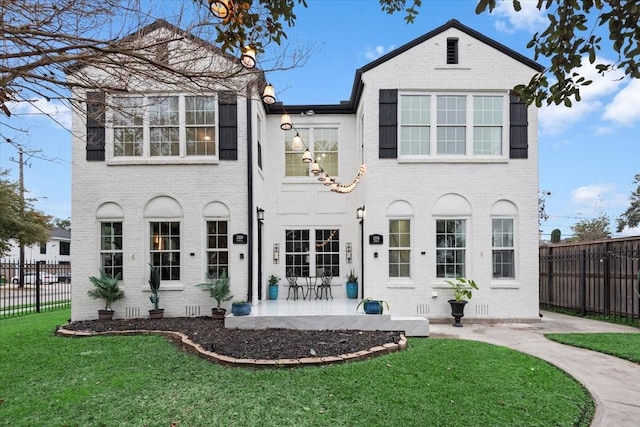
[0, 310, 593, 427]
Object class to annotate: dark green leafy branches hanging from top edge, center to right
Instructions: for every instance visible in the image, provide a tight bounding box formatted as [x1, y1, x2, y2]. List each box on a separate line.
[206, 0, 640, 107]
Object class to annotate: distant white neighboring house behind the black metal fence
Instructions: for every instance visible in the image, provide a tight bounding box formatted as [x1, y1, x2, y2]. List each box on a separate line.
[3, 228, 71, 264]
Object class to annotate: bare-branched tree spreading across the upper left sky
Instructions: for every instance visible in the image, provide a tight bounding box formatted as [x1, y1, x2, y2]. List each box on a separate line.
[0, 0, 307, 123]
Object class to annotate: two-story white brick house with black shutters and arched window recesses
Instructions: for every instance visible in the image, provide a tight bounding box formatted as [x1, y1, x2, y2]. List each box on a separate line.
[69, 20, 542, 320]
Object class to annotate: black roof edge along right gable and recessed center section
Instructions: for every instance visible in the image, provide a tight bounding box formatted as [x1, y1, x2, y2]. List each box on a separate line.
[267, 19, 544, 114]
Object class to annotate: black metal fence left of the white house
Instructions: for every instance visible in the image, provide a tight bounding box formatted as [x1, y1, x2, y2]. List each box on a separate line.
[0, 260, 71, 318]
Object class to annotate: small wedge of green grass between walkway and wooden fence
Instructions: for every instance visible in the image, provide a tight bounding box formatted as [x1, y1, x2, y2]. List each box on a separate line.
[545, 333, 640, 363]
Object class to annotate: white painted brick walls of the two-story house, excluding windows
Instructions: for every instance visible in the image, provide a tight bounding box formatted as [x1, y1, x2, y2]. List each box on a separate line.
[72, 20, 538, 320]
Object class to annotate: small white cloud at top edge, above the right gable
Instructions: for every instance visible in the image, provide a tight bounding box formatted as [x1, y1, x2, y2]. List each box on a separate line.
[491, 0, 549, 34]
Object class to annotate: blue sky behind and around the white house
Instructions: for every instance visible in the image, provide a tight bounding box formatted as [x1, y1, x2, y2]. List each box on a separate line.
[0, 0, 640, 239]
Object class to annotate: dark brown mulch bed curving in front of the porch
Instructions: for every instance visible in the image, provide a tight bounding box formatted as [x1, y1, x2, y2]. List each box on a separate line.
[62, 317, 401, 359]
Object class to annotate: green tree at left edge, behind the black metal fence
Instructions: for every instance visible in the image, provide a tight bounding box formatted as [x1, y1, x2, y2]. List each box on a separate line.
[0, 171, 50, 256]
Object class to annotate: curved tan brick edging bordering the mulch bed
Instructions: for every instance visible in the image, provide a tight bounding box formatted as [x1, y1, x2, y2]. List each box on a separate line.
[56, 326, 407, 368]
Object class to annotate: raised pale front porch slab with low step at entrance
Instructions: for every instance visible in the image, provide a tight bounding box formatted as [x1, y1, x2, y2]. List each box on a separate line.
[224, 298, 429, 337]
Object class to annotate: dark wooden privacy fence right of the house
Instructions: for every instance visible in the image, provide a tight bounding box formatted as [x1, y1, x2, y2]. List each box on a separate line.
[539, 237, 640, 319]
